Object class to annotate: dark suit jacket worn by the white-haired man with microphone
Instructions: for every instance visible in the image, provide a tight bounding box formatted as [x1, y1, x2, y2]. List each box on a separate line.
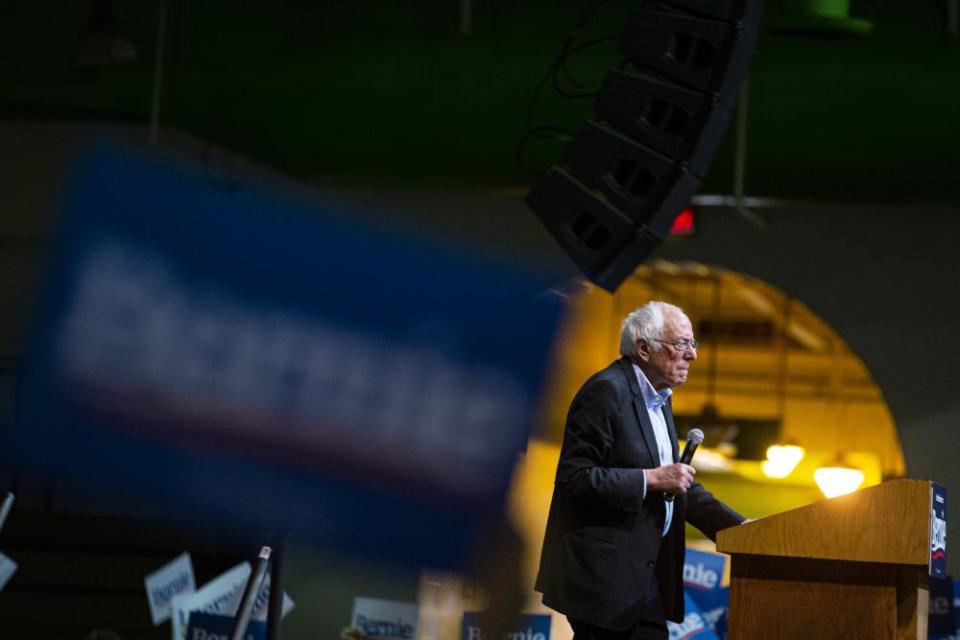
[536, 358, 743, 630]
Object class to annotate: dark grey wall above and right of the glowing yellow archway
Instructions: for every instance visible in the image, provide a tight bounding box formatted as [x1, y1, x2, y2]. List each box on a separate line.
[658, 205, 960, 575]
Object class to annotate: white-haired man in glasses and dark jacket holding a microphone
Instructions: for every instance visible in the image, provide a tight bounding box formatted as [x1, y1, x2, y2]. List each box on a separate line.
[537, 301, 744, 640]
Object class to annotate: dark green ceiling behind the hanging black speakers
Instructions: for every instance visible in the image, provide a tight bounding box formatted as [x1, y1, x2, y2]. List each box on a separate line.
[0, 0, 960, 201]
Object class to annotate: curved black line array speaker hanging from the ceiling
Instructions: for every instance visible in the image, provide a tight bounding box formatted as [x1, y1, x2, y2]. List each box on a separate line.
[527, 0, 763, 291]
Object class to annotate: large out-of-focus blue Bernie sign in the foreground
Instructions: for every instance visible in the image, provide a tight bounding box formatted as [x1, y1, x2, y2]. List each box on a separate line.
[12, 147, 561, 564]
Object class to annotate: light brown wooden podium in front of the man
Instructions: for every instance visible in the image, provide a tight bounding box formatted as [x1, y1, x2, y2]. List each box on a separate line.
[717, 480, 933, 640]
